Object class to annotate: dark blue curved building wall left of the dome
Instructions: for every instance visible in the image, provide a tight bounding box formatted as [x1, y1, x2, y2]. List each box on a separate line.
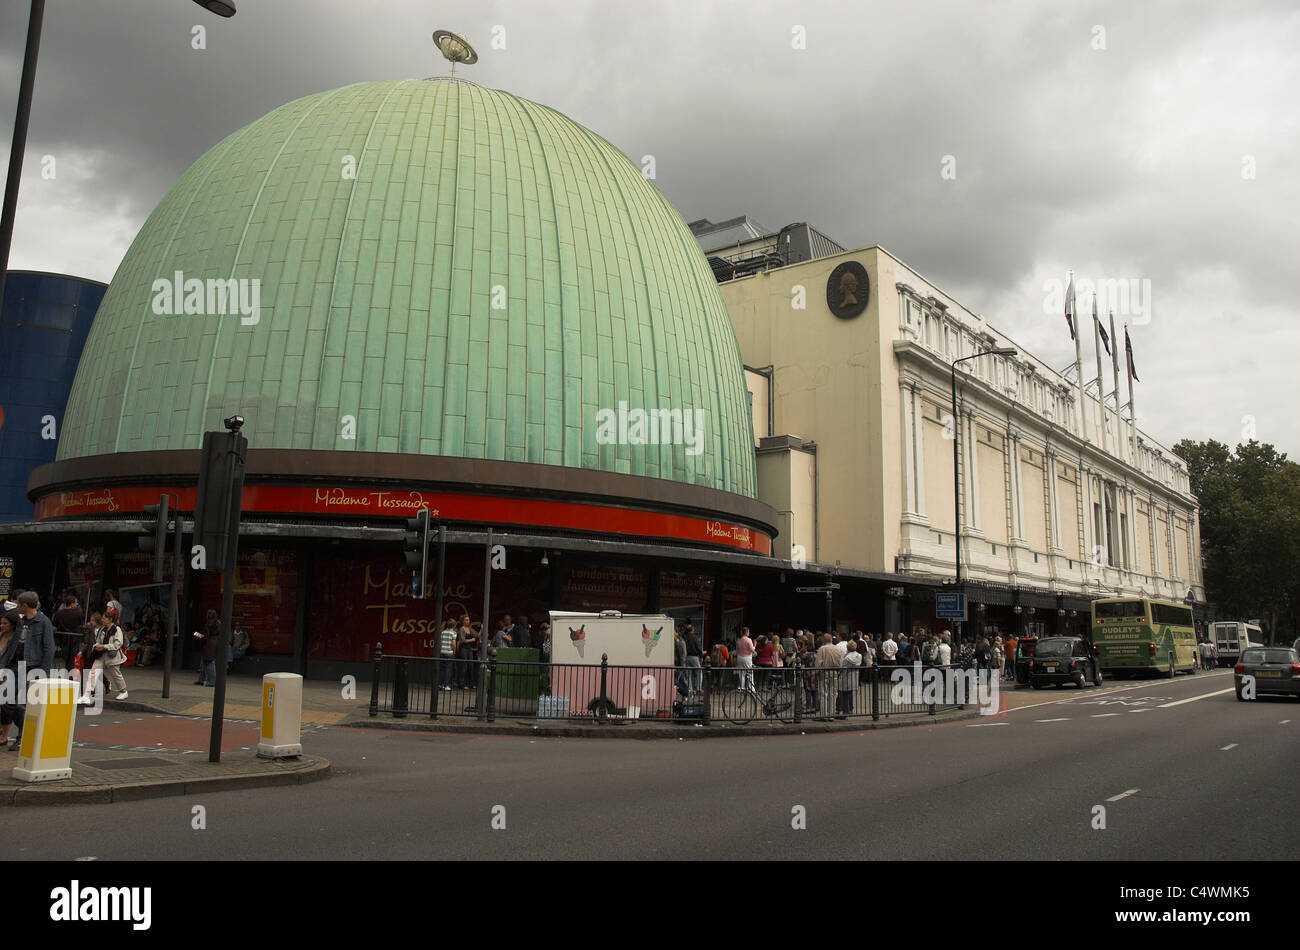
[0, 270, 108, 522]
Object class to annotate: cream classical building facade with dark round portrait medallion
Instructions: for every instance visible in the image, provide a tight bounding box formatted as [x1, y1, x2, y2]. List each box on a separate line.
[719, 247, 1205, 602]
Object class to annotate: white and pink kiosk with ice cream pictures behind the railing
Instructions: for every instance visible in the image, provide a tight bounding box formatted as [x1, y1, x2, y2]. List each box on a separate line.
[550, 611, 676, 717]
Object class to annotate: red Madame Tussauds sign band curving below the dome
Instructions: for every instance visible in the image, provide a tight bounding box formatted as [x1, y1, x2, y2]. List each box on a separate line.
[36, 485, 772, 555]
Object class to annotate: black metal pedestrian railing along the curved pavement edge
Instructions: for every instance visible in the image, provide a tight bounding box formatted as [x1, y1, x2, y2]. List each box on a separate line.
[369, 645, 982, 725]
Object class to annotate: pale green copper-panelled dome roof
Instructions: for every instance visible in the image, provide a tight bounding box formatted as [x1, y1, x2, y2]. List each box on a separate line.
[59, 79, 755, 498]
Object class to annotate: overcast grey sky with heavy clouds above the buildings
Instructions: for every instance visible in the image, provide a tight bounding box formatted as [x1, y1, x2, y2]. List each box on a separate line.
[0, 0, 1300, 457]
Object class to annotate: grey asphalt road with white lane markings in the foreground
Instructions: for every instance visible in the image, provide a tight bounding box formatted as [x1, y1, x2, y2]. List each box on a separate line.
[0, 672, 1300, 860]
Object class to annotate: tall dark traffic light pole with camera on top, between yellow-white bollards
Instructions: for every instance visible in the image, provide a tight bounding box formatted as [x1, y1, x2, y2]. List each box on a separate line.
[194, 416, 248, 762]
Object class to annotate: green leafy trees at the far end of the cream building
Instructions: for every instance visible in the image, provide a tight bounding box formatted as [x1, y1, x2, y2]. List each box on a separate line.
[1174, 439, 1300, 642]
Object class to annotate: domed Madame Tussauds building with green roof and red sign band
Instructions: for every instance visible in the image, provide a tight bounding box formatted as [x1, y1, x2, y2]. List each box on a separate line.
[5, 79, 819, 676]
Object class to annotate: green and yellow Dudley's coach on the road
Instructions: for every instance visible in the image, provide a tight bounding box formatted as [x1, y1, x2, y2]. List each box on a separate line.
[1092, 597, 1200, 680]
